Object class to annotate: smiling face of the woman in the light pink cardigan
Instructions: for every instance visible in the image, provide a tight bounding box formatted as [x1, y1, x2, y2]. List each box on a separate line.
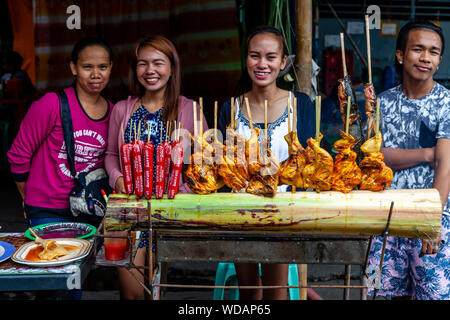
[136, 47, 172, 92]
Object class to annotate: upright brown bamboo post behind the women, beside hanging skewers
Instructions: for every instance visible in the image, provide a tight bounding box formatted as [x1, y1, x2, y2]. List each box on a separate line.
[295, 0, 313, 96]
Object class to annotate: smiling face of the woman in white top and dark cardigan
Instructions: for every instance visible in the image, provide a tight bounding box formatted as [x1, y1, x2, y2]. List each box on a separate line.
[247, 33, 287, 87]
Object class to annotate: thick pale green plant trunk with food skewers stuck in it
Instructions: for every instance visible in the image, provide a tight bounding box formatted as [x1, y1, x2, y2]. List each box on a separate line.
[105, 189, 442, 239]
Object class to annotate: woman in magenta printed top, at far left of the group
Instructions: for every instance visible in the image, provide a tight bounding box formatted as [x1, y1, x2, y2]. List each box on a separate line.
[8, 38, 113, 227]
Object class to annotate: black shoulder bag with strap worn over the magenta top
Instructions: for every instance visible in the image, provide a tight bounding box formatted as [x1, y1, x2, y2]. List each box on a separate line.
[59, 91, 112, 217]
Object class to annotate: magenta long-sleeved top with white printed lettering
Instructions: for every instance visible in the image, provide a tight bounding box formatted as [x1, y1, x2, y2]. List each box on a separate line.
[8, 87, 113, 209]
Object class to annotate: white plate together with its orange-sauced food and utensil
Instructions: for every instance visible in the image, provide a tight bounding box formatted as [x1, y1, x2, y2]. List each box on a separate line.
[11, 238, 92, 267]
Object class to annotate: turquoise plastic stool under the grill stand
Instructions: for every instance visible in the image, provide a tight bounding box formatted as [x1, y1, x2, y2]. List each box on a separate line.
[213, 262, 300, 300]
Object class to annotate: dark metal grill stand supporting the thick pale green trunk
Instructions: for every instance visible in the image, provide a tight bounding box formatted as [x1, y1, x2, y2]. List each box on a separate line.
[94, 195, 404, 300]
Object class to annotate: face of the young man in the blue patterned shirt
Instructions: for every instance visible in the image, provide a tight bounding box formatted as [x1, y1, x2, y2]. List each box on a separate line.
[396, 29, 442, 81]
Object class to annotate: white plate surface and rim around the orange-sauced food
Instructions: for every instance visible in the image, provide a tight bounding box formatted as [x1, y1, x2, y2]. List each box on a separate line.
[11, 238, 92, 267]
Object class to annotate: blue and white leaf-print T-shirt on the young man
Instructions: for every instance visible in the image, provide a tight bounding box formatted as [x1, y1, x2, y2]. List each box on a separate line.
[380, 82, 450, 215]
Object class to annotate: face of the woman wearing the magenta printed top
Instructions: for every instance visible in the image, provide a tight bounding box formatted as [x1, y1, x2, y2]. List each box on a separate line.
[70, 45, 112, 94]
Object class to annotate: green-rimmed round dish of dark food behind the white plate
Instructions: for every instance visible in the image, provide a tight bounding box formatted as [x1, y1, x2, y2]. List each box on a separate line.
[24, 222, 97, 240]
